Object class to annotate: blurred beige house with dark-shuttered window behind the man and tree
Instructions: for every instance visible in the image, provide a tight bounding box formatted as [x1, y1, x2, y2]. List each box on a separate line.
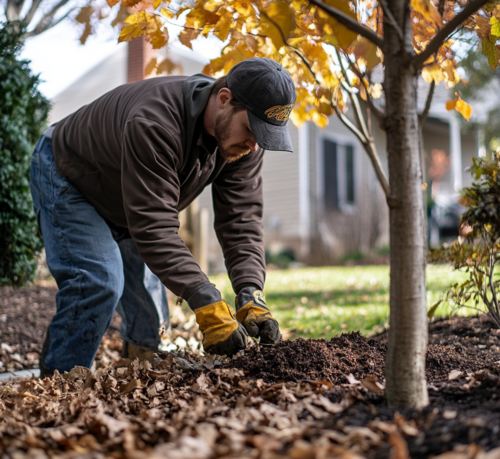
[50, 39, 479, 272]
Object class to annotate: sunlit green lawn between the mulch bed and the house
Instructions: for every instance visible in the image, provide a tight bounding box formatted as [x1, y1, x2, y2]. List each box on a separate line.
[211, 265, 474, 339]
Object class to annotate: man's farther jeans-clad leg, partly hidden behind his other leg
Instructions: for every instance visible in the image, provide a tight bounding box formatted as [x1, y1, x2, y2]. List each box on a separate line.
[117, 238, 169, 352]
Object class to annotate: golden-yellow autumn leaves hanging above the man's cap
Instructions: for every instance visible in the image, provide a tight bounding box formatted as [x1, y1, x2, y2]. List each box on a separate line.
[68, 0, 500, 135]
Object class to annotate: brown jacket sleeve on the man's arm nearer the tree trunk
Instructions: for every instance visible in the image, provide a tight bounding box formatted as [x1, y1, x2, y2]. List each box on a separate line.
[212, 149, 266, 292]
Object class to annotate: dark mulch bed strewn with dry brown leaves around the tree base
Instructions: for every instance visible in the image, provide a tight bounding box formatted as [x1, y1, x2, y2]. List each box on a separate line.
[0, 290, 500, 459]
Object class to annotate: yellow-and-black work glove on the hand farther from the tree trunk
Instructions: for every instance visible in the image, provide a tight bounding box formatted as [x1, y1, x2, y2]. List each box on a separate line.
[188, 284, 248, 356]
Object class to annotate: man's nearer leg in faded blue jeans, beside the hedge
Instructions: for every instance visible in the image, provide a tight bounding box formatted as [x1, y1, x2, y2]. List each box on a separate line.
[30, 137, 124, 374]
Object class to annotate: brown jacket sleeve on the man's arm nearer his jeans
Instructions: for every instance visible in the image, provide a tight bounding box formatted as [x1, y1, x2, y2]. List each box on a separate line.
[121, 119, 210, 298]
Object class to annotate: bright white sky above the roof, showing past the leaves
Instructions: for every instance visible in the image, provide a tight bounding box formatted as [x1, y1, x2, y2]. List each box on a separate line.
[21, 16, 223, 99]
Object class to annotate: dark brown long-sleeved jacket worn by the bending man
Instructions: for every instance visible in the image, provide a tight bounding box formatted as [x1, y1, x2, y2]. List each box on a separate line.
[52, 75, 265, 298]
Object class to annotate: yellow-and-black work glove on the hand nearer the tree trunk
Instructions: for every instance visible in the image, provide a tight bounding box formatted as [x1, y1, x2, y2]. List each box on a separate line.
[236, 286, 281, 344]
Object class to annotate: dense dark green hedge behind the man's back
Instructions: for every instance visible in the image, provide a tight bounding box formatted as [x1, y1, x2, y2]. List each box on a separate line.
[0, 23, 50, 286]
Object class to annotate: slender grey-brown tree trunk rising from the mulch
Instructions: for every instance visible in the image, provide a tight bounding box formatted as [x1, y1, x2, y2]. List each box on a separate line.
[384, 0, 429, 408]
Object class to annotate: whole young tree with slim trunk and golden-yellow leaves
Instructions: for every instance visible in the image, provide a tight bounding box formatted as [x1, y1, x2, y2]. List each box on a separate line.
[108, 0, 500, 408]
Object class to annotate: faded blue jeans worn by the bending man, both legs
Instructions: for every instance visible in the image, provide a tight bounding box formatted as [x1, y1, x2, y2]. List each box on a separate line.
[30, 136, 169, 372]
